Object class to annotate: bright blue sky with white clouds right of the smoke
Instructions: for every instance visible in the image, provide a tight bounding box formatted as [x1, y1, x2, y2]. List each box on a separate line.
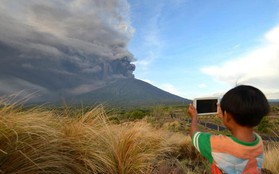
[128, 0, 279, 99]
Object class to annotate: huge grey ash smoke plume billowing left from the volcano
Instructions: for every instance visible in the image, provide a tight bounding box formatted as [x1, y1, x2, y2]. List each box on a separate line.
[0, 0, 135, 101]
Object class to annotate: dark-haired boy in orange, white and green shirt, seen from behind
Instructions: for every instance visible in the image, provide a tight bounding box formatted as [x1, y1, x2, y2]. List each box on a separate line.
[188, 85, 269, 174]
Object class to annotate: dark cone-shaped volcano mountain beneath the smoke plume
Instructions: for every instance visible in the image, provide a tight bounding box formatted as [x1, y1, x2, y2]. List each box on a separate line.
[70, 78, 190, 107]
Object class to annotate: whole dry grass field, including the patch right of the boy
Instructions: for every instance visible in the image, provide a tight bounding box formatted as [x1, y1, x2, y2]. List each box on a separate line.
[0, 104, 279, 174]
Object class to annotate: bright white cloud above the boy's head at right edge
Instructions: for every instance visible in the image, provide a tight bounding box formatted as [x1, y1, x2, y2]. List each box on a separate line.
[201, 26, 279, 98]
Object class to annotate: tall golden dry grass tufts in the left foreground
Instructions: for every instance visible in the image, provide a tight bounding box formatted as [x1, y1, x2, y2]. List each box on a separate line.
[0, 102, 197, 174]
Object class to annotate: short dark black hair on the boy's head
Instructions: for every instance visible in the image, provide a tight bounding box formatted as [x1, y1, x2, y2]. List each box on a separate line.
[220, 85, 270, 127]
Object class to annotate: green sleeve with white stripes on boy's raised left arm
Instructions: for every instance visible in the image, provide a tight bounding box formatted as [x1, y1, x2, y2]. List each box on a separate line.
[192, 132, 213, 164]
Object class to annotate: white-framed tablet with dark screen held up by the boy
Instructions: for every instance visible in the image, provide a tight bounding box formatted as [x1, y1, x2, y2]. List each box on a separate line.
[193, 97, 220, 115]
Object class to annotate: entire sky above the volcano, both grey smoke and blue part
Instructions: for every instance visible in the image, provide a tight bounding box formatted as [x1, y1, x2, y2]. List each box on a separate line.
[0, 0, 279, 99]
